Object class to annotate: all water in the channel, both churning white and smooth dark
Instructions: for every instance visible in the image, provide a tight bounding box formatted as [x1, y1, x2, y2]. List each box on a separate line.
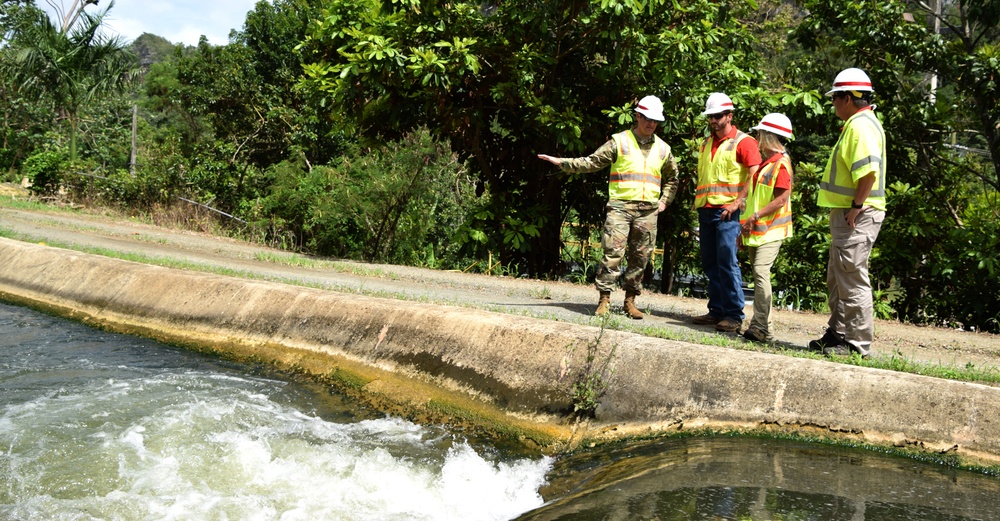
[0, 303, 1000, 521]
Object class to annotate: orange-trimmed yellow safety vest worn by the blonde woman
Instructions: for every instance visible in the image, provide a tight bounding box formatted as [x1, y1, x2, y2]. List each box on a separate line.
[740, 154, 792, 246]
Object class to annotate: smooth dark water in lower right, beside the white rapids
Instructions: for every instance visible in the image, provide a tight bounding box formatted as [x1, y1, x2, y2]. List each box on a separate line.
[518, 437, 1000, 521]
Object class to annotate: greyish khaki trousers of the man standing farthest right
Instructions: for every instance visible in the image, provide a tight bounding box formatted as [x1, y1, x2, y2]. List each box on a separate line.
[826, 208, 885, 355]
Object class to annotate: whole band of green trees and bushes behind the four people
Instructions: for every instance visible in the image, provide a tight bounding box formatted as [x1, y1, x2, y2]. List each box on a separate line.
[0, 0, 1000, 331]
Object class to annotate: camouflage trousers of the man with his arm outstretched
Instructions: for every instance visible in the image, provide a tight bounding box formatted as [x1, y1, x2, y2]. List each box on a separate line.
[596, 200, 657, 295]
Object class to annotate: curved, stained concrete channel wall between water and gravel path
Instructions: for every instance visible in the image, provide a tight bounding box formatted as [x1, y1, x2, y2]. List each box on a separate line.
[0, 238, 1000, 464]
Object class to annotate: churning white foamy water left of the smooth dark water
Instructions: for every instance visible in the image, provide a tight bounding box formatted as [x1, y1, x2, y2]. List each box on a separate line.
[0, 305, 552, 520]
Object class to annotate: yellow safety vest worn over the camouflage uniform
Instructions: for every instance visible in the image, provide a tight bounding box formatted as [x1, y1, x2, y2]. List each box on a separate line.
[608, 130, 670, 203]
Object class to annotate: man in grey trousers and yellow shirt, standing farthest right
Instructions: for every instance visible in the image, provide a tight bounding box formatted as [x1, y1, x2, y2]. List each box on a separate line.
[809, 68, 886, 358]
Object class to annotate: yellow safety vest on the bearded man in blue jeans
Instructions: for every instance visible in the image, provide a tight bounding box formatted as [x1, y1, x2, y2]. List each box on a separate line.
[694, 131, 750, 208]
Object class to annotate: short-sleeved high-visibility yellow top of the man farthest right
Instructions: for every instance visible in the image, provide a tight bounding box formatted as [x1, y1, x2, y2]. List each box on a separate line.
[816, 110, 886, 211]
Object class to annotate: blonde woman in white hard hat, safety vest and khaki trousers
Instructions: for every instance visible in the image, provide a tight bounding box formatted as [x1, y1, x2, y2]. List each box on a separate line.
[740, 114, 792, 342]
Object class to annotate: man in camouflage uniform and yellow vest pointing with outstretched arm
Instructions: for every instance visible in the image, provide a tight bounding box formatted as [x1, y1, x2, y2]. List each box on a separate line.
[538, 96, 677, 320]
